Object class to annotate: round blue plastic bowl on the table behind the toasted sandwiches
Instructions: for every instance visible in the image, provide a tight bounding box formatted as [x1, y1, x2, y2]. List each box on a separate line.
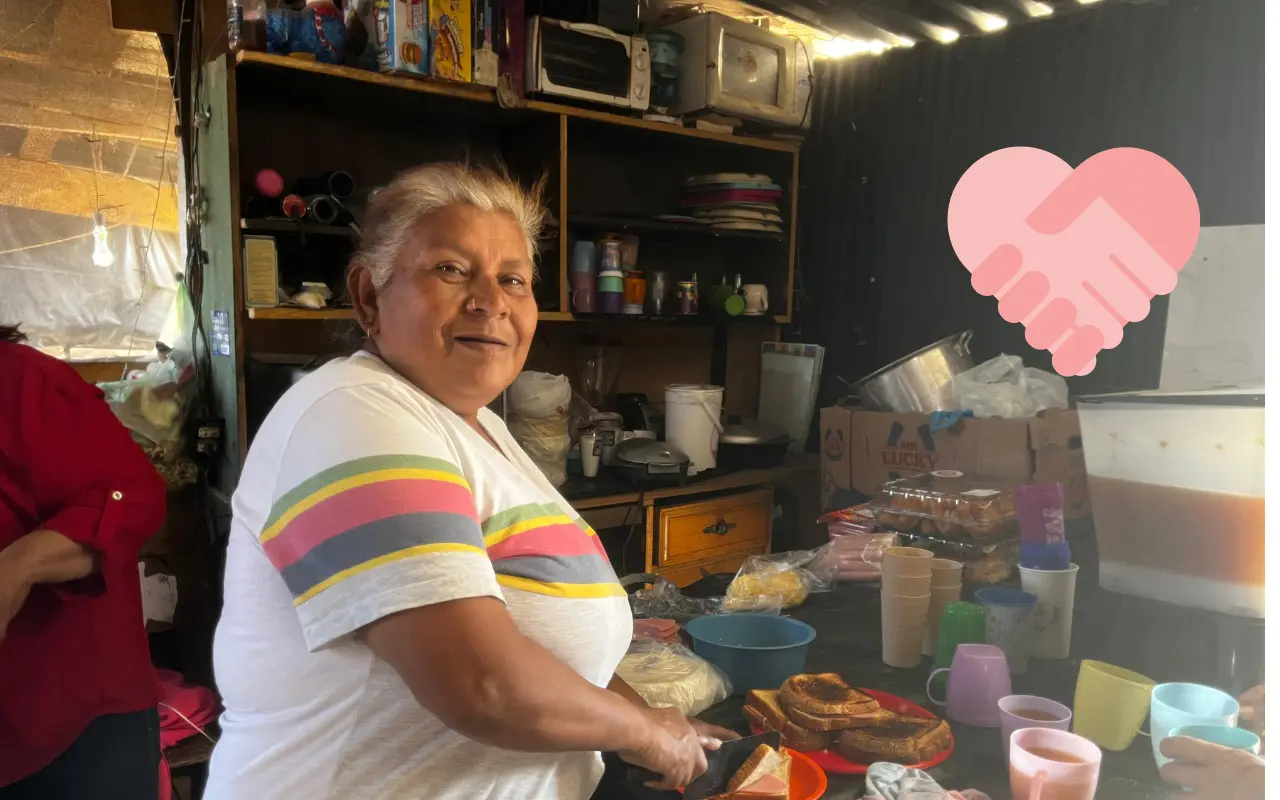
[685, 614, 817, 695]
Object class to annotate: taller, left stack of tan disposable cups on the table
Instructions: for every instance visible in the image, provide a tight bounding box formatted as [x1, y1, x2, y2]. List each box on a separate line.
[881, 548, 933, 667]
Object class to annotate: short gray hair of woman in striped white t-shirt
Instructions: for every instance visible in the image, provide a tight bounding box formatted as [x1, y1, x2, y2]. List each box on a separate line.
[351, 161, 545, 288]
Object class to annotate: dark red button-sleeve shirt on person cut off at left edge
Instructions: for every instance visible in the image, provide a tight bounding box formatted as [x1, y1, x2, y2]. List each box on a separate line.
[0, 342, 165, 786]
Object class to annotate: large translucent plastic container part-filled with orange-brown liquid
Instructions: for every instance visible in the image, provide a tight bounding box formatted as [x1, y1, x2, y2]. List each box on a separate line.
[1079, 389, 1266, 618]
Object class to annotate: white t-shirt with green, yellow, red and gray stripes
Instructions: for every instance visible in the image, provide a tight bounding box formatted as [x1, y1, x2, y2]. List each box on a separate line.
[205, 353, 631, 800]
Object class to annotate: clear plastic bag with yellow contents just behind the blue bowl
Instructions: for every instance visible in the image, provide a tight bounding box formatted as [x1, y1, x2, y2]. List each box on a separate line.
[722, 544, 840, 612]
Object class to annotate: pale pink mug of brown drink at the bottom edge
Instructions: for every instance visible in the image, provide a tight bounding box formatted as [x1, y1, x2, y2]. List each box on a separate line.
[1009, 728, 1102, 800]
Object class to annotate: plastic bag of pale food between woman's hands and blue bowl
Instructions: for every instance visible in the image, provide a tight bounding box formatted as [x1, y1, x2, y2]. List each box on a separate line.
[616, 639, 733, 717]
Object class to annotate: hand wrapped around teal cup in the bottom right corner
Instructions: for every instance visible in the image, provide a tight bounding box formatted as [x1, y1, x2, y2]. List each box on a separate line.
[1160, 736, 1265, 800]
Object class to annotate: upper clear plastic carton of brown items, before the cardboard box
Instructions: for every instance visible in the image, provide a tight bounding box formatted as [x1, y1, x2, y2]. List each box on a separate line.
[869, 470, 1018, 540]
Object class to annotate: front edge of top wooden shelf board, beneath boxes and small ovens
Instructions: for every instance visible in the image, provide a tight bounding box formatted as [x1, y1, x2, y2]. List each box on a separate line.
[236, 50, 800, 152]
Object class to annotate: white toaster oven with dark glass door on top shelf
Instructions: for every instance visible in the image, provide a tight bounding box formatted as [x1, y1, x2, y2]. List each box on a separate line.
[525, 15, 649, 110]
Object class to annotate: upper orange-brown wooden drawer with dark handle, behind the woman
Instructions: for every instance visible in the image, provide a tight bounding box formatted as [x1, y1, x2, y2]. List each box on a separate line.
[657, 489, 773, 567]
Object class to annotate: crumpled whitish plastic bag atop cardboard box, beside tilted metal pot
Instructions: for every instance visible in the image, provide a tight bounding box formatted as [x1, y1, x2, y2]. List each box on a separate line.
[951, 355, 1066, 420]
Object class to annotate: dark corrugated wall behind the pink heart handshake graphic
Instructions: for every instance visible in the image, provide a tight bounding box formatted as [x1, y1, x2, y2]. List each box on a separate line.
[800, 0, 1263, 403]
